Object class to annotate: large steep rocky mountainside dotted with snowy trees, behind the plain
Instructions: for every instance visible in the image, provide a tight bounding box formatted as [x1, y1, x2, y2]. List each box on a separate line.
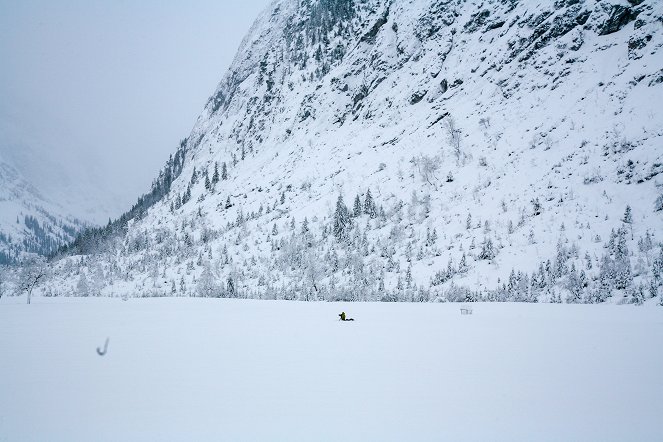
[20, 0, 663, 302]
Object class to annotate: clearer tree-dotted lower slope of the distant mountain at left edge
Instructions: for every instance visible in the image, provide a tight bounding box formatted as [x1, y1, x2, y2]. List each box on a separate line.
[0, 159, 86, 265]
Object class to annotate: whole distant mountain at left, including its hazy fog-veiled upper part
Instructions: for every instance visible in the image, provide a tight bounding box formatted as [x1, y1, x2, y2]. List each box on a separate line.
[0, 110, 132, 263]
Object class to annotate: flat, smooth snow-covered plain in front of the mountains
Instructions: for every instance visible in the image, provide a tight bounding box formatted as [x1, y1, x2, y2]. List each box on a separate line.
[0, 298, 663, 441]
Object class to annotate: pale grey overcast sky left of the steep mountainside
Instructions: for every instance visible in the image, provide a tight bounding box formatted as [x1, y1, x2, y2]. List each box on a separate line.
[0, 0, 270, 221]
